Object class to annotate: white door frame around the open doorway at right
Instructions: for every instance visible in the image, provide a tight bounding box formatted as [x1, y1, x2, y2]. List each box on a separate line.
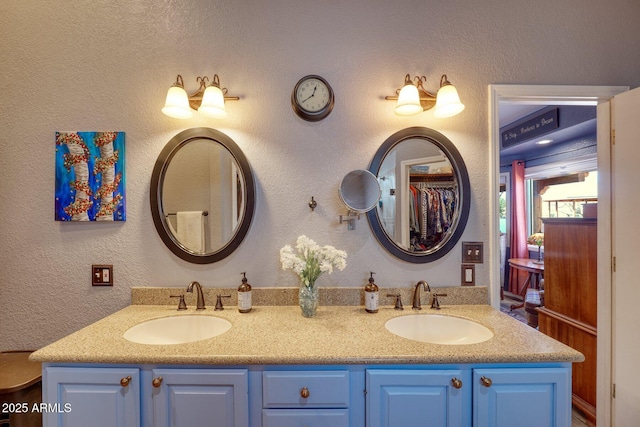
[488, 84, 629, 427]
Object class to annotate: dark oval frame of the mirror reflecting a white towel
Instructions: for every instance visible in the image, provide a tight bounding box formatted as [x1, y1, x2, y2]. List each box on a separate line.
[149, 127, 255, 264]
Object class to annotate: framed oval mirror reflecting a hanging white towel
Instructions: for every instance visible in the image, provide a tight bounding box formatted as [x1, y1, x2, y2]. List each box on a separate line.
[150, 128, 255, 264]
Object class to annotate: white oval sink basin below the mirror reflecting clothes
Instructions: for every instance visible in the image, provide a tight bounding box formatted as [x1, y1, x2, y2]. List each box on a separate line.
[384, 314, 493, 345]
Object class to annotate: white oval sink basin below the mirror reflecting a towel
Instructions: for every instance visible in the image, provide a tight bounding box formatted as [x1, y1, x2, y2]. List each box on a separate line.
[124, 315, 231, 345]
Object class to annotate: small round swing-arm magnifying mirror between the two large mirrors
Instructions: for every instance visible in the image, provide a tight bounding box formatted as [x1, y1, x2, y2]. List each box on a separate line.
[340, 169, 380, 213]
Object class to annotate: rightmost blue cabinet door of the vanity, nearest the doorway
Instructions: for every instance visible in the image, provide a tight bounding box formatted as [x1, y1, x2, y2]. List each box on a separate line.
[473, 368, 571, 427]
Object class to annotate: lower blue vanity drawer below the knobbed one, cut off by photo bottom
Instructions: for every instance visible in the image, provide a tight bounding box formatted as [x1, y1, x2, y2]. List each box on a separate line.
[262, 409, 349, 427]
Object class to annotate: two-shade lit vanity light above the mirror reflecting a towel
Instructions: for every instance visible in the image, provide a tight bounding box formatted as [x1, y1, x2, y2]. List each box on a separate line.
[162, 74, 240, 119]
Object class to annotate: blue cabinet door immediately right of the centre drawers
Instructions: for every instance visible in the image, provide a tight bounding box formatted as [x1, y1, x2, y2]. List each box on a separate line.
[366, 369, 472, 427]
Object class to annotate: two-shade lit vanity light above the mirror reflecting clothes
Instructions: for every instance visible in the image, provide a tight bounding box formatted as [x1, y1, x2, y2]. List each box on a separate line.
[384, 74, 464, 118]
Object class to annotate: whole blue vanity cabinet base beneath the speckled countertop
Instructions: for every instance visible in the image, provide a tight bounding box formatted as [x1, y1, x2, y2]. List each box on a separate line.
[43, 362, 571, 427]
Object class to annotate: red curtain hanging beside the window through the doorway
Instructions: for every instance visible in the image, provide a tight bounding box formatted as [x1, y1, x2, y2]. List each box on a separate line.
[509, 160, 529, 293]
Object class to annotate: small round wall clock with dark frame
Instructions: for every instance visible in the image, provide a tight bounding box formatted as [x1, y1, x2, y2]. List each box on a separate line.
[291, 75, 334, 122]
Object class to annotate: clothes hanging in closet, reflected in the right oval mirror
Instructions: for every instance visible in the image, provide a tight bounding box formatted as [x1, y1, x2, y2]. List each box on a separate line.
[409, 182, 457, 251]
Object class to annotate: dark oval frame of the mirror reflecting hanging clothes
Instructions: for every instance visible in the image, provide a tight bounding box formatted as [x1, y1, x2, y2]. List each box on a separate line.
[367, 127, 471, 264]
